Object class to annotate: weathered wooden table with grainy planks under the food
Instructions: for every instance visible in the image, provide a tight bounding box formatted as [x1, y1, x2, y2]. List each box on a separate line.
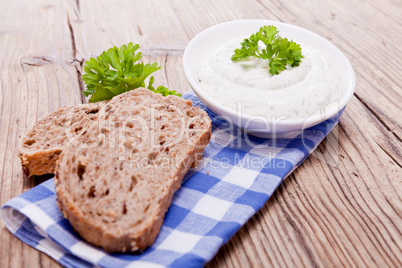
[0, 0, 402, 268]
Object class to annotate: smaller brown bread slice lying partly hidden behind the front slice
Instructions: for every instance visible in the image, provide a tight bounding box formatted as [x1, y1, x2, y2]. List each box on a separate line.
[19, 103, 104, 176]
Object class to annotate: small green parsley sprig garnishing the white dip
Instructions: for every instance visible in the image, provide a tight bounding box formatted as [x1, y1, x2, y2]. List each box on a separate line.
[232, 25, 303, 75]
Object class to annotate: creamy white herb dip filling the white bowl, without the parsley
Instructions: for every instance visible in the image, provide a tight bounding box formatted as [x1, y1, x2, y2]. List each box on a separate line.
[198, 38, 345, 119]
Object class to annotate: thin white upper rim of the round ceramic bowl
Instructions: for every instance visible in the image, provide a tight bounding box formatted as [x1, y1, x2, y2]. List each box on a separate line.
[183, 19, 355, 125]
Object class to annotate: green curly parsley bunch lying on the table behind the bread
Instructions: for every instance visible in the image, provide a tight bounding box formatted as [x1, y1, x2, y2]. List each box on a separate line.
[82, 43, 181, 102]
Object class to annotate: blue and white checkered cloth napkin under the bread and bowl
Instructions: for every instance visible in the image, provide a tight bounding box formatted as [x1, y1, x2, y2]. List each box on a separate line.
[2, 91, 340, 267]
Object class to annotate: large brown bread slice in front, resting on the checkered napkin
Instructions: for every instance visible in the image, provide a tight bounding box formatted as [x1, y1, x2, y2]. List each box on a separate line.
[55, 89, 211, 252]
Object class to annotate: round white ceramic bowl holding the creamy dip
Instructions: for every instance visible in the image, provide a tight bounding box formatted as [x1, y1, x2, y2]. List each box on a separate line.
[183, 20, 355, 138]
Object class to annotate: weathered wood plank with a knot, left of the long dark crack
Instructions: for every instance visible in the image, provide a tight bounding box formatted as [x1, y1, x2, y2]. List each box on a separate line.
[0, 1, 80, 267]
